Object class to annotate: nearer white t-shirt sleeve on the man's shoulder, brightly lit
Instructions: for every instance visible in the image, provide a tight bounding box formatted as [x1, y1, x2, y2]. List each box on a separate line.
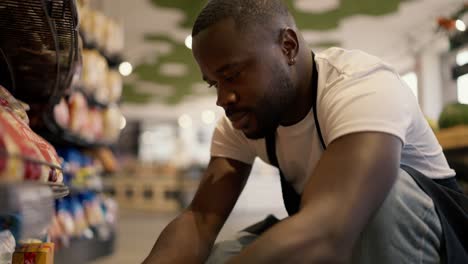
[317, 67, 417, 144]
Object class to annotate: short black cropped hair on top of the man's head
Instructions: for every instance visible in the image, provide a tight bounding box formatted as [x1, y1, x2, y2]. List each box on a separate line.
[192, 0, 292, 37]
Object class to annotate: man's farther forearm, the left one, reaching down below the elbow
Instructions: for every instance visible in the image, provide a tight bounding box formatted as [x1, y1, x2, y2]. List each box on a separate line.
[143, 211, 216, 264]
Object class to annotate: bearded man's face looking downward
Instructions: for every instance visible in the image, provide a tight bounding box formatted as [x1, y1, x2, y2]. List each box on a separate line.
[193, 19, 296, 139]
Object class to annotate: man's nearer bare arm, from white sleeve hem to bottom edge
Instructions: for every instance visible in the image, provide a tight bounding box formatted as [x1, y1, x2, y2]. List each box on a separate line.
[230, 132, 402, 264]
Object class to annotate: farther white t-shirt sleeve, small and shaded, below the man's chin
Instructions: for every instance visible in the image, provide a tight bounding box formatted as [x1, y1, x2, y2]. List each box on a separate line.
[211, 116, 256, 164]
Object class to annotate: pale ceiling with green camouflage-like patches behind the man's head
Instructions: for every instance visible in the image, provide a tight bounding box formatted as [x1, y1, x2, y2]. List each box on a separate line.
[93, 0, 463, 118]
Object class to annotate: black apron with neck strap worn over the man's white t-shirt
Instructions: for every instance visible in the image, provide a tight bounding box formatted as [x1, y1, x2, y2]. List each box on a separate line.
[244, 53, 468, 264]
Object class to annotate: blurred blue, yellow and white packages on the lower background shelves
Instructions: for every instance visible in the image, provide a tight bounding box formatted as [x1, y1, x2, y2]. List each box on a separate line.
[49, 148, 117, 263]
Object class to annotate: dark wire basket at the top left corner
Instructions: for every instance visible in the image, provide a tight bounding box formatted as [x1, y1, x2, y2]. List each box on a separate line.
[0, 0, 79, 104]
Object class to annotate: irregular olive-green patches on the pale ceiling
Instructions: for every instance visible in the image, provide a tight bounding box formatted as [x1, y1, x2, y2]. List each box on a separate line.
[128, 0, 409, 104]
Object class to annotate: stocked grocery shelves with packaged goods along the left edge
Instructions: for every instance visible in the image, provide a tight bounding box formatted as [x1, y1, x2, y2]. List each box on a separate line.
[0, 0, 123, 264]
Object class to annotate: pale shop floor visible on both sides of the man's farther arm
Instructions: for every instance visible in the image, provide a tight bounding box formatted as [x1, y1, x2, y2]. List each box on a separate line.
[89, 170, 286, 264]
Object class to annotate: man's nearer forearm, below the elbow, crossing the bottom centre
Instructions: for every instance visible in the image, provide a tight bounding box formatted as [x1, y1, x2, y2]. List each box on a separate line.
[229, 207, 351, 264]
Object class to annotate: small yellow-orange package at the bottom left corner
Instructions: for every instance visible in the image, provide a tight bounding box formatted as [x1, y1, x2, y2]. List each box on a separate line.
[12, 243, 54, 264]
